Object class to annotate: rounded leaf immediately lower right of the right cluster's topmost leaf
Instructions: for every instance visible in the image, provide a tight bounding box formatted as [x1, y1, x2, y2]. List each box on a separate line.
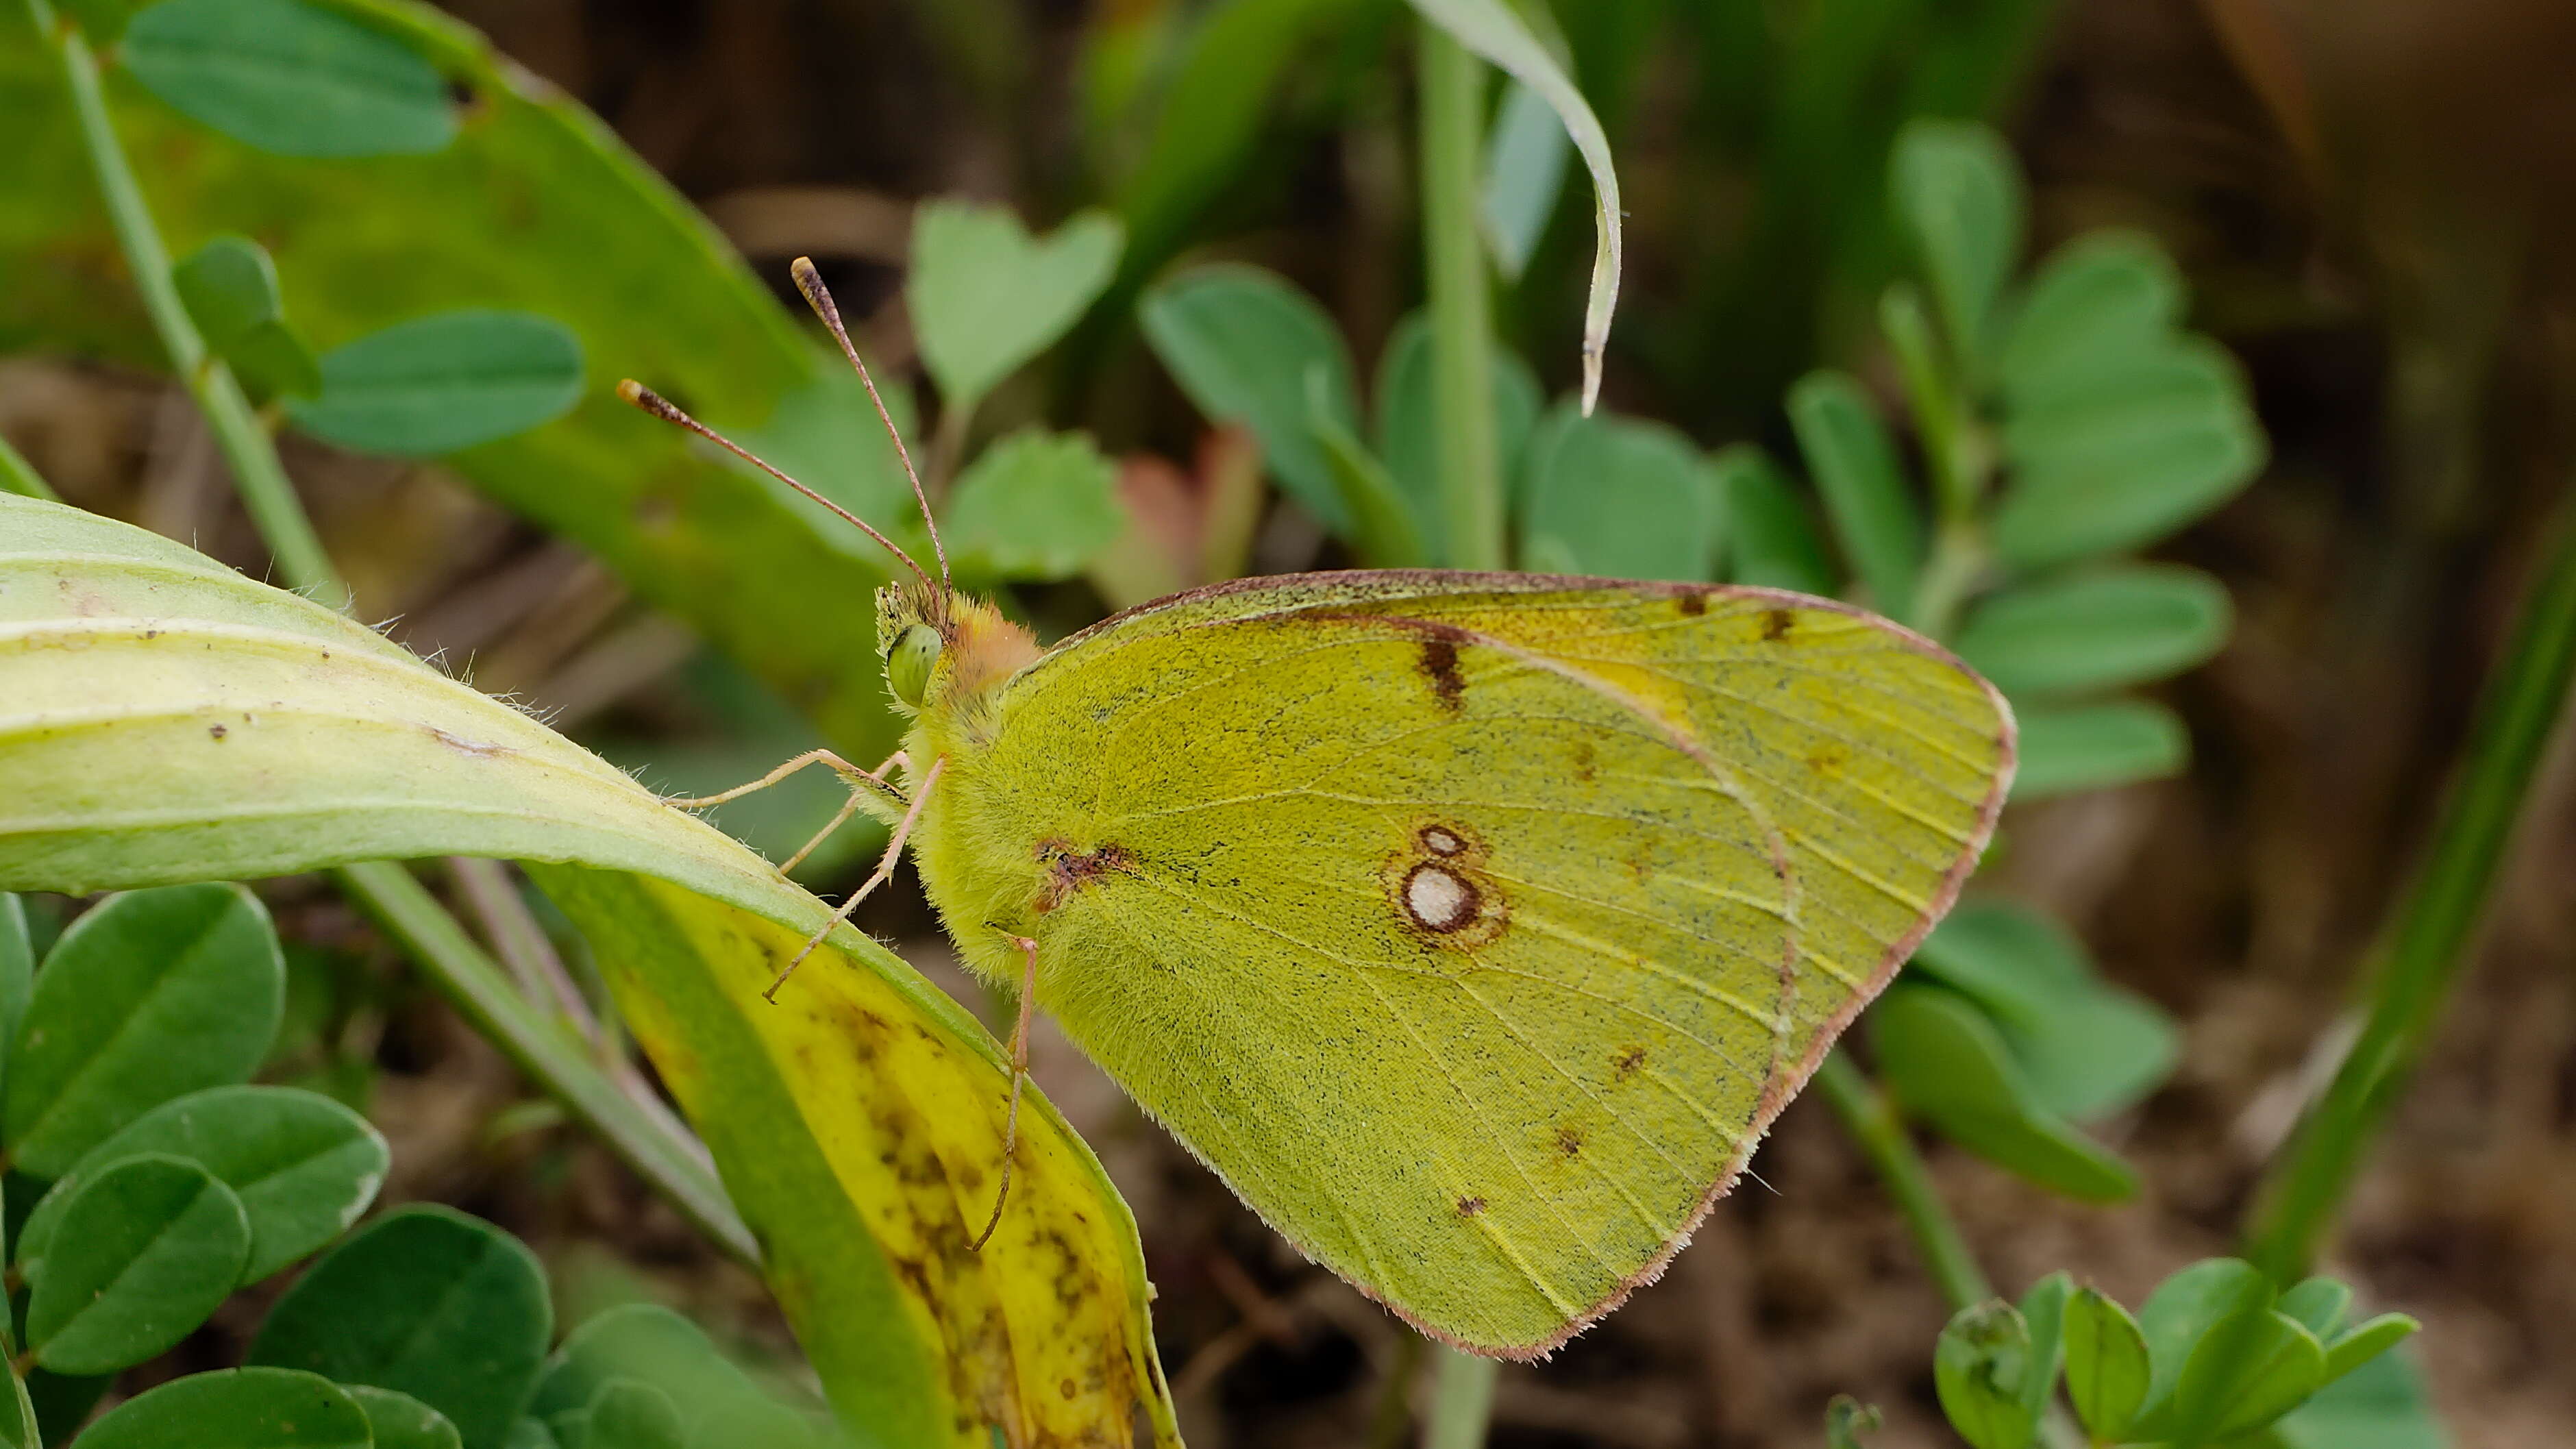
[1999, 232, 2182, 397]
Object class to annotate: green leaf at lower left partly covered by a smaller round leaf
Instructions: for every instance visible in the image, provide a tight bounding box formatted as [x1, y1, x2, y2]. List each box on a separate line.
[18, 1085, 389, 1284]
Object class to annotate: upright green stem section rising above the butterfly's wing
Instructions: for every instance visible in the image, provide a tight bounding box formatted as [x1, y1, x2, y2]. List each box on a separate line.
[1417, 21, 1504, 570]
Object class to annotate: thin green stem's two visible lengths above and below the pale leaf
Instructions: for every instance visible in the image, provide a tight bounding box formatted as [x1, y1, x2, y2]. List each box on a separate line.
[28, 0, 760, 1266]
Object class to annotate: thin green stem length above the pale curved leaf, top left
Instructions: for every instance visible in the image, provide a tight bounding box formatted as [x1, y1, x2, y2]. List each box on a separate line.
[28, 0, 348, 608]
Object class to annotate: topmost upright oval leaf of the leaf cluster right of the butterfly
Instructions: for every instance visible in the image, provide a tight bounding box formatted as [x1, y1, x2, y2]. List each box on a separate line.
[1888, 119, 2022, 366]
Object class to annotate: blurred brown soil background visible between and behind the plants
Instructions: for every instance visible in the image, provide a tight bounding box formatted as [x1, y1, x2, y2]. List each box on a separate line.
[0, 0, 2576, 1449]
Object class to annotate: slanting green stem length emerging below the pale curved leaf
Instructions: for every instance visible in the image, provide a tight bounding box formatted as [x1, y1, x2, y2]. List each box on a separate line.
[332, 861, 760, 1269]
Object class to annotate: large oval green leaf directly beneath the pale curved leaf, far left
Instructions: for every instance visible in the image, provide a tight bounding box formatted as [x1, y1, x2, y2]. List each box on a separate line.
[0, 882, 286, 1178]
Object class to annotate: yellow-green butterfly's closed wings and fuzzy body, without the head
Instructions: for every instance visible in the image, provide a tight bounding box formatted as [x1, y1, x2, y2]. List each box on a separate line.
[922, 572, 2012, 1357]
